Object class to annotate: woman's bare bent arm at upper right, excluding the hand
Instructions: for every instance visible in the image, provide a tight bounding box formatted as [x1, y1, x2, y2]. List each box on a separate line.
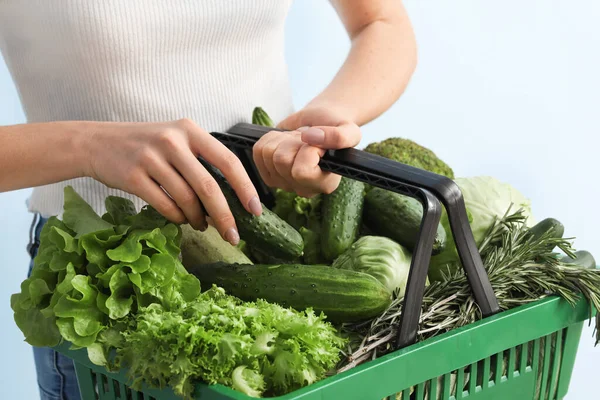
[307, 0, 417, 126]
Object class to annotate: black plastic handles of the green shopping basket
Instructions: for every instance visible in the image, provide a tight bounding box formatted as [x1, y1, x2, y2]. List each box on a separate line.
[211, 123, 500, 348]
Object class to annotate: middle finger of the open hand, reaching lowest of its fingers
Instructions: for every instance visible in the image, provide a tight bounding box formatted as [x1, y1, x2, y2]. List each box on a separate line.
[173, 151, 240, 246]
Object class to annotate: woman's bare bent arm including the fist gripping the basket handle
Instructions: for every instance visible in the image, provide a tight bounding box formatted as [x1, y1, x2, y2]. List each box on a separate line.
[253, 0, 417, 197]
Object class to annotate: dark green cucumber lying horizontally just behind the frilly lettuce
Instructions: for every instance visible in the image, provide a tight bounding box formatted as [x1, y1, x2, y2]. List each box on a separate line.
[188, 263, 392, 323]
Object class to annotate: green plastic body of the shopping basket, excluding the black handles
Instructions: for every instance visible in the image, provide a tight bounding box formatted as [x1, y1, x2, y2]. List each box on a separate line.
[56, 297, 589, 400]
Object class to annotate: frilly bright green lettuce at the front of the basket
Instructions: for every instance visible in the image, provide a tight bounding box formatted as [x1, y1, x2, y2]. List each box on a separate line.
[120, 286, 345, 397]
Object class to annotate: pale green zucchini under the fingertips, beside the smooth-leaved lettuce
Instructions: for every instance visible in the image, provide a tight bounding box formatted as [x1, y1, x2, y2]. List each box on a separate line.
[180, 224, 252, 267]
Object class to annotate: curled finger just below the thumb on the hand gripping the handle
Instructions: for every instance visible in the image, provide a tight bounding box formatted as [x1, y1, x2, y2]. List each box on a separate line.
[291, 144, 341, 197]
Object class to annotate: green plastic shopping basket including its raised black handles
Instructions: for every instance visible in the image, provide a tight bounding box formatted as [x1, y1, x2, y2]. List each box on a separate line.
[55, 124, 590, 400]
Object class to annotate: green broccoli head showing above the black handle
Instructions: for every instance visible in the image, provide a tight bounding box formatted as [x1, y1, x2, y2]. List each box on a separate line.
[364, 137, 454, 179]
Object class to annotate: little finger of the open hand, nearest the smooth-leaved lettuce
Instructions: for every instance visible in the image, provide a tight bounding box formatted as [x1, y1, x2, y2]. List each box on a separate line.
[128, 172, 187, 224]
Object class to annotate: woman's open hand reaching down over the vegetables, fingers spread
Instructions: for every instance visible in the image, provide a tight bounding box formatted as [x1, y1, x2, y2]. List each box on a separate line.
[84, 119, 262, 245]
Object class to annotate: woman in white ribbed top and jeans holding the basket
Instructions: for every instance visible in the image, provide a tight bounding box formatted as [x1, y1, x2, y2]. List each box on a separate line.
[0, 0, 416, 400]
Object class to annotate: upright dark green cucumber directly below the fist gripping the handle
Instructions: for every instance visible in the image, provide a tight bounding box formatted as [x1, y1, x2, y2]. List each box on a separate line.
[321, 177, 365, 261]
